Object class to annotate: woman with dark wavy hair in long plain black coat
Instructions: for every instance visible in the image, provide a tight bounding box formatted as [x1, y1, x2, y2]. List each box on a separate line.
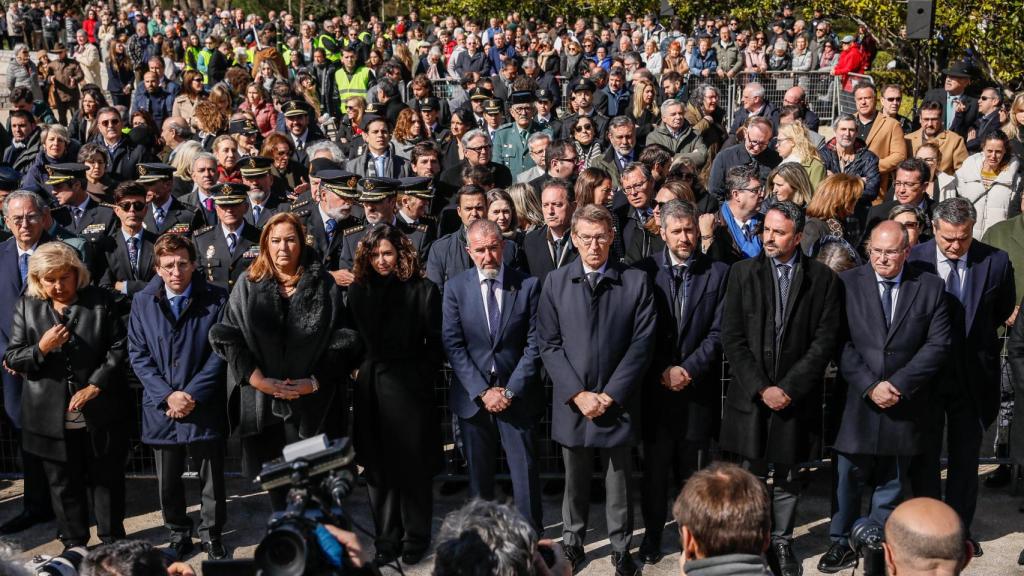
[348, 225, 442, 564]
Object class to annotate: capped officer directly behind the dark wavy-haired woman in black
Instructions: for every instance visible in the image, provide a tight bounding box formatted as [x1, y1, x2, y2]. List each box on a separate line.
[335, 177, 433, 286]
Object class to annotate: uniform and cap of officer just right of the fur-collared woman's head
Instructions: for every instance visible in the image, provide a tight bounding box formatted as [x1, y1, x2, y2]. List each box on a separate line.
[292, 170, 364, 272]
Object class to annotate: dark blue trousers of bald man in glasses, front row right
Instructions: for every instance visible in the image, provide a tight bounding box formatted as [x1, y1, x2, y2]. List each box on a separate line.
[828, 452, 911, 545]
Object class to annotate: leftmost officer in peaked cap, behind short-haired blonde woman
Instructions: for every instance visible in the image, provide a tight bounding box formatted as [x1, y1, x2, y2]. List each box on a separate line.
[45, 163, 118, 242]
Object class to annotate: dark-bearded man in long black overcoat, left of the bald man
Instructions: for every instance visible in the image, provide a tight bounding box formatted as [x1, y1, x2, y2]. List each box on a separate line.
[716, 202, 842, 576]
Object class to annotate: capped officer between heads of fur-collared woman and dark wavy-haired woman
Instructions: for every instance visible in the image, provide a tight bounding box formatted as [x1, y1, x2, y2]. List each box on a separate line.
[293, 169, 362, 272]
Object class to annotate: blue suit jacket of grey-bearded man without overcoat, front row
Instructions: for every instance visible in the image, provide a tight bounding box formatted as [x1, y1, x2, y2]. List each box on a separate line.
[441, 266, 545, 425]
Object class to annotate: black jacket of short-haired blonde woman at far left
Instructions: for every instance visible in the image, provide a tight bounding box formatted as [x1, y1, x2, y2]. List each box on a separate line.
[4, 286, 126, 461]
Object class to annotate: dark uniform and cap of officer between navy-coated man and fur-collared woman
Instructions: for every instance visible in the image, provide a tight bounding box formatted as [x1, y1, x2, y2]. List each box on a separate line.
[193, 182, 259, 290]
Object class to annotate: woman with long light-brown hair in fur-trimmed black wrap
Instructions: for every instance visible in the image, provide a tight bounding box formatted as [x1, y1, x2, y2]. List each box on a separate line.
[210, 211, 358, 510]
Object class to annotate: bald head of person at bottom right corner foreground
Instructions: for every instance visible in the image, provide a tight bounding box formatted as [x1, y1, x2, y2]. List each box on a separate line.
[884, 498, 974, 576]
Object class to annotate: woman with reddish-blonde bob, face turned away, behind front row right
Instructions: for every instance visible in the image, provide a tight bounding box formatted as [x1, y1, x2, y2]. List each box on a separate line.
[800, 173, 864, 257]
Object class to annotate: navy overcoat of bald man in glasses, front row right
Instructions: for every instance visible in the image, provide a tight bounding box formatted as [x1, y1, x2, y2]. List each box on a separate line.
[835, 264, 950, 455]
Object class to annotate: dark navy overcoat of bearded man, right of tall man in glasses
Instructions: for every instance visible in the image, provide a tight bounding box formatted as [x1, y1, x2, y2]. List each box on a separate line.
[637, 249, 729, 443]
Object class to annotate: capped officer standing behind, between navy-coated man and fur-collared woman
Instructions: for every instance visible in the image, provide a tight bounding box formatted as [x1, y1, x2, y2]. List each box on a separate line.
[194, 182, 259, 290]
